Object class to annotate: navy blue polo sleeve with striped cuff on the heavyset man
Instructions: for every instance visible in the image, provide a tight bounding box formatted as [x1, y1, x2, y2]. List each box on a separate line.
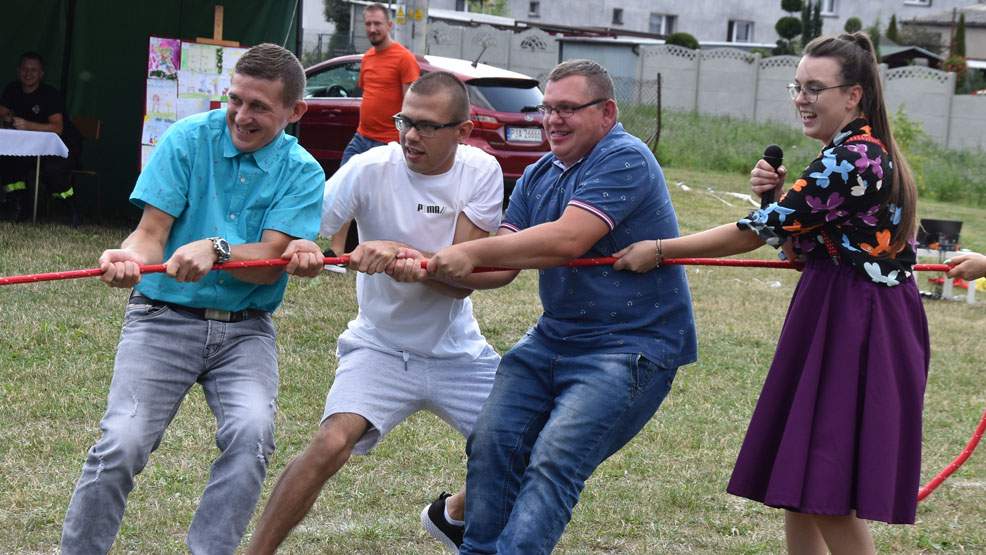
[568, 148, 648, 231]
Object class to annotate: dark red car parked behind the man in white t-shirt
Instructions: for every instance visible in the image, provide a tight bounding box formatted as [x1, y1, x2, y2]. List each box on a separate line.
[296, 54, 549, 195]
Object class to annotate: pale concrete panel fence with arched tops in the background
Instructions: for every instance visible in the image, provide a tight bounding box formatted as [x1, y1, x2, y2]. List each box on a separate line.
[420, 22, 986, 150]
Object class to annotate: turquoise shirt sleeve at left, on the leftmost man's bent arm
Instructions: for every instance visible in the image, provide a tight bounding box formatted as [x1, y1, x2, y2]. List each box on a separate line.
[130, 122, 194, 218]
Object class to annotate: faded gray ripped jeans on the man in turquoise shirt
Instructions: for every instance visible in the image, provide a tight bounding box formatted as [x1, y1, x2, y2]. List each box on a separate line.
[62, 304, 278, 555]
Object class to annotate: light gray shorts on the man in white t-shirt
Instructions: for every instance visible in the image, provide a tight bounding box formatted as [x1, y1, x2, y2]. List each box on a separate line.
[322, 332, 500, 455]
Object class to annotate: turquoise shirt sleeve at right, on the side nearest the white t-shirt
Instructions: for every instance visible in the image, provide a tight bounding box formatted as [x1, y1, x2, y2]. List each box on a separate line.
[263, 159, 325, 240]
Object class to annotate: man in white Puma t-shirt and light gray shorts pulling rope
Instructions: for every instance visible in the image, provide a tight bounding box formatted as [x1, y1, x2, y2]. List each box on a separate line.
[248, 72, 503, 553]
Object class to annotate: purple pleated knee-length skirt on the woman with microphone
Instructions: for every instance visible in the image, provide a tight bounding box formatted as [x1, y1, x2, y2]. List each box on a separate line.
[727, 260, 930, 524]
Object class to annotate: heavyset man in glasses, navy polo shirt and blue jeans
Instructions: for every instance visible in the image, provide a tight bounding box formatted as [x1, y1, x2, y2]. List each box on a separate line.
[426, 60, 697, 554]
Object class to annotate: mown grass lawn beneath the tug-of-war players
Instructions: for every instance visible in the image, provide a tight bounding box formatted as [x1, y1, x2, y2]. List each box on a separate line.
[0, 170, 986, 554]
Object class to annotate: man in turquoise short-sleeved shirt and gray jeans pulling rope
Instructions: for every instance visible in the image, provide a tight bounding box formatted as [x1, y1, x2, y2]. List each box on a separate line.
[62, 44, 325, 555]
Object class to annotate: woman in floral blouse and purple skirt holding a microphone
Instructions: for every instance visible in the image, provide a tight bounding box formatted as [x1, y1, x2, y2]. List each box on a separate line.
[614, 33, 930, 553]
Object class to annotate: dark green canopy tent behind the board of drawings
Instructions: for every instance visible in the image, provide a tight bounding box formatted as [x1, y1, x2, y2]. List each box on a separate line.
[0, 0, 302, 219]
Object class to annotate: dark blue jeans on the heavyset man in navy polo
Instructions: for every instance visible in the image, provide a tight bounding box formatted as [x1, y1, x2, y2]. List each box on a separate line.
[459, 334, 677, 555]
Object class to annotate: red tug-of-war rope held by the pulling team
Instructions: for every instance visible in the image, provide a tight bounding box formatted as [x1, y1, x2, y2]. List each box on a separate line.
[0, 256, 986, 501]
